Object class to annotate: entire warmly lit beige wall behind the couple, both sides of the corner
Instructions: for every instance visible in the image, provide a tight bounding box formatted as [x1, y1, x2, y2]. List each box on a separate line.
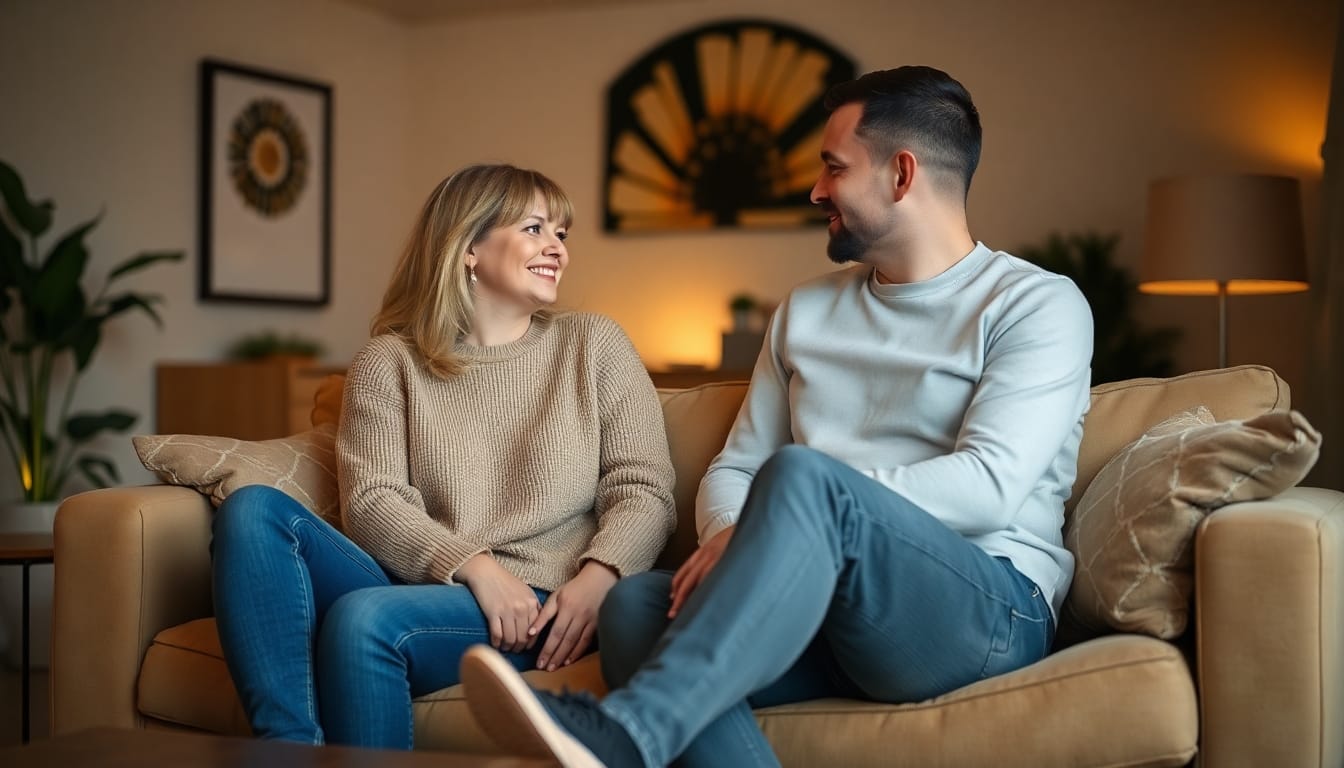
[0, 0, 1337, 492]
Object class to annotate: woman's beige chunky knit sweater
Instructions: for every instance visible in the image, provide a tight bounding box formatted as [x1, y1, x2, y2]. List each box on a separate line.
[336, 313, 676, 590]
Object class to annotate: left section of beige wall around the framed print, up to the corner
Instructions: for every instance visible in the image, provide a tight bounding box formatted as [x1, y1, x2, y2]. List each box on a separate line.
[0, 0, 417, 498]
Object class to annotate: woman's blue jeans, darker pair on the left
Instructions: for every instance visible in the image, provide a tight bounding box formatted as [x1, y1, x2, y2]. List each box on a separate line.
[211, 486, 547, 749]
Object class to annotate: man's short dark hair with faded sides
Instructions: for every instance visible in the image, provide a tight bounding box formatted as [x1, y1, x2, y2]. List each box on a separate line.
[825, 66, 980, 198]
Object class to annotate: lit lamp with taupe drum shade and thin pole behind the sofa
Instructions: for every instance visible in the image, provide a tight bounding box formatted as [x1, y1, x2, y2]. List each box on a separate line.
[1138, 174, 1308, 367]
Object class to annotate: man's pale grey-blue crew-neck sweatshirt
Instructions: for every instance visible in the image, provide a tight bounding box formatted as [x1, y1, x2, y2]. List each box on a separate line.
[696, 243, 1093, 616]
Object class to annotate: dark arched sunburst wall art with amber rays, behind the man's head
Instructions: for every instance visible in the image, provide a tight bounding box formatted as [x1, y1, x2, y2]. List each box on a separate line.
[603, 20, 855, 231]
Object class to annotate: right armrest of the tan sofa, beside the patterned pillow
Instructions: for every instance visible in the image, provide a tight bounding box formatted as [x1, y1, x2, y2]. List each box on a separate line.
[1195, 488, 1344, 768]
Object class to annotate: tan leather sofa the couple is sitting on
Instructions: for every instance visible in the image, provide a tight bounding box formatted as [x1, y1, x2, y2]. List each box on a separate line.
[51, 366, 1344, 768]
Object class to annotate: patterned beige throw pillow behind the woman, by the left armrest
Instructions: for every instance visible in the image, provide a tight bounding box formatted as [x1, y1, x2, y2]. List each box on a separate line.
[130, 424, 340, 527]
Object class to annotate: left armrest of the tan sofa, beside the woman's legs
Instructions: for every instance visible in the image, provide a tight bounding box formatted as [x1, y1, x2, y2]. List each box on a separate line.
[51, 486, 212, 734]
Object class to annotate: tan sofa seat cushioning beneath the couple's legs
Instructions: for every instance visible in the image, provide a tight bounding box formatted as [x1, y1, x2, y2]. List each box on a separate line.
[137, 619, 1199, 768]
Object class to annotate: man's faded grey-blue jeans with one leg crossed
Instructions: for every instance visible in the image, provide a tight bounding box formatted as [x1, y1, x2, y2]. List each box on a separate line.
[598, 445, 1054, 765]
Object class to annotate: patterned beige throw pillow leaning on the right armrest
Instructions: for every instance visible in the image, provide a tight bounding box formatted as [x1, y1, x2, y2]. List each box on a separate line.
[1064, 406, 1321, 639]
